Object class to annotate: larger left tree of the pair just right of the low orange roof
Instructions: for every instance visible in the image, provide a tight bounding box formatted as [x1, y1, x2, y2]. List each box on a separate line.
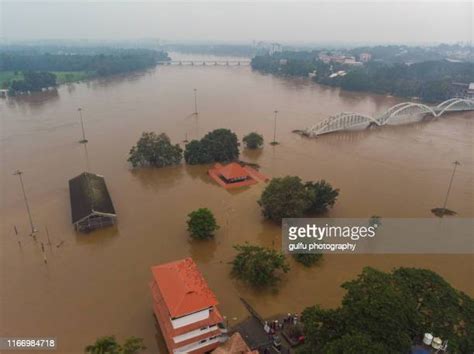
[258, 176, 311, 222]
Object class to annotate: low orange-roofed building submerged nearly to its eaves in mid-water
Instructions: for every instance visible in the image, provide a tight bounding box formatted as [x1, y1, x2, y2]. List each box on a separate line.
[208, 162, 268, 189]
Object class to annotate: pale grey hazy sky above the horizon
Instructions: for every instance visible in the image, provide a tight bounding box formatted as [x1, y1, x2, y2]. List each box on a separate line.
[0, 0, 474, 43]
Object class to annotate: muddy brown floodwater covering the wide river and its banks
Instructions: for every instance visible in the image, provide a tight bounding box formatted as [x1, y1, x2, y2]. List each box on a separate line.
[0, 53, 474, 353]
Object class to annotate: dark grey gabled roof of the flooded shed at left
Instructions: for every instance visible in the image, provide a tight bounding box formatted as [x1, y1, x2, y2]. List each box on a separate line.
[69, 172, 115, 224]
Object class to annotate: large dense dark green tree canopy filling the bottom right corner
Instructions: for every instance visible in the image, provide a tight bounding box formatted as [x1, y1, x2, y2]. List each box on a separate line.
[302, 268, 474, 353]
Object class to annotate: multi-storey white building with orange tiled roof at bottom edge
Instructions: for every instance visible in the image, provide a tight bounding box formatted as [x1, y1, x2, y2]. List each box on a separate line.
[150, 258, 227, 353]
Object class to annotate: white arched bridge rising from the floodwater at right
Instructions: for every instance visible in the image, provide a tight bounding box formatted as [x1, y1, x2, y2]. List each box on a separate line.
[301, 98, 474, 137]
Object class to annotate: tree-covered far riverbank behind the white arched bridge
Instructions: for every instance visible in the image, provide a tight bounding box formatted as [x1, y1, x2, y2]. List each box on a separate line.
[251, 52, 474, 102]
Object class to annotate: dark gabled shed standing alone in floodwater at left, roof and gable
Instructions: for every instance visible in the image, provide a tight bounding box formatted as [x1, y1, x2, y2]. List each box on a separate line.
[69, 172, 117, 232]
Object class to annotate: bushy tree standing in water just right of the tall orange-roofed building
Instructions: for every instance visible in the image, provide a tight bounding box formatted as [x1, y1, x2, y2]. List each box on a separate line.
[232, 244, 290, 287]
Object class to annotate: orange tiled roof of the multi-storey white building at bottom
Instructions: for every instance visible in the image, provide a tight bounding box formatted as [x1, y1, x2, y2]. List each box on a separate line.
[151, 258, 217, 318]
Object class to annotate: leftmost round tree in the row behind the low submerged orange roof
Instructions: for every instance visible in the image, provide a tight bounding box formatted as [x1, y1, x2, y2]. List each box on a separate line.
[128, 132, 183, 167]
